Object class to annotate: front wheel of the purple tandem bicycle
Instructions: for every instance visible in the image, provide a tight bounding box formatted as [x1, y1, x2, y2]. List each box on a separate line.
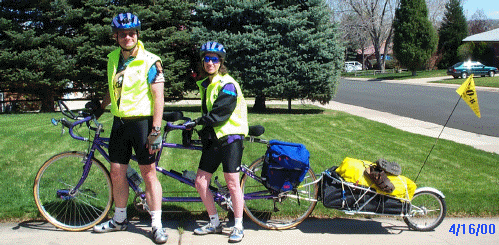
[33, 152, 113, 231]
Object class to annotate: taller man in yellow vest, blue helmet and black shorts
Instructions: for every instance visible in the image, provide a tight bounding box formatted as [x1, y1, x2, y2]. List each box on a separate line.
[94, 13, 168, 243]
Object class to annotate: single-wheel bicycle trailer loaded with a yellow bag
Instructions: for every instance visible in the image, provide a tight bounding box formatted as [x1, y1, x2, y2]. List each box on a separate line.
[319, 157, 447, 231]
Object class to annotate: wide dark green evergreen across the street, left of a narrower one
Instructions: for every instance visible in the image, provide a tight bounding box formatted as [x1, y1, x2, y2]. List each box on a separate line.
[393, 0, 438, 76]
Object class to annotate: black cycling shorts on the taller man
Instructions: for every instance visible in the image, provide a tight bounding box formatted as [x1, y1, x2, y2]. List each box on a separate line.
[109, 117, 154, 165]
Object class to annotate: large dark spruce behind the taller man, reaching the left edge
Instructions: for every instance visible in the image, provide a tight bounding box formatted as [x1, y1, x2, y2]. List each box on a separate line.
[0, 0, 193, 111]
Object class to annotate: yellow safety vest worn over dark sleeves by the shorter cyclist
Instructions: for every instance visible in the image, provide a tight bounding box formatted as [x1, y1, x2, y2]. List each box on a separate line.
[197, 75, 248, 139]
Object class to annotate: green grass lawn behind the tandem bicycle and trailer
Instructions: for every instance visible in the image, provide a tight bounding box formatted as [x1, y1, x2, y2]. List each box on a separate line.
[0, 105, 499, 220]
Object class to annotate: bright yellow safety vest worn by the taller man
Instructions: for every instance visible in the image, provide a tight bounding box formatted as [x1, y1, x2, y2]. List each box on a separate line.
[107, 41, 161, 117]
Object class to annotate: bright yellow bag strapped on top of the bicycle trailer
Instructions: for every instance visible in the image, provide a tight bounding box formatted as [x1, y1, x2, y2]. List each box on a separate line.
[336, 157, 417, 200]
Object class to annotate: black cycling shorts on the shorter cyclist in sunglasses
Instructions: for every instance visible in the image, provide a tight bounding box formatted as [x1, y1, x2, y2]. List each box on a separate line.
[199, 140, 243, 174]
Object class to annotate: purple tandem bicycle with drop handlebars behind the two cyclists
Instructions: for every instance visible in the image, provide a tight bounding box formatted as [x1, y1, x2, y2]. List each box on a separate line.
[33, 101, 320, 231]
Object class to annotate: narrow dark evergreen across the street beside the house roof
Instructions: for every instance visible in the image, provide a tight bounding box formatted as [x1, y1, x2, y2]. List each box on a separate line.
[438, 0, 468, 69]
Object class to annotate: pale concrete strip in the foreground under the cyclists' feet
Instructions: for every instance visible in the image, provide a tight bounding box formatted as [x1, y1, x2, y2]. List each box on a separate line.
[0, 216, 499, 245]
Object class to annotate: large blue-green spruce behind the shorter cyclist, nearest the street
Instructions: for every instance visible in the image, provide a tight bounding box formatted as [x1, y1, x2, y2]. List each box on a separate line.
[193, 0, 343, 109]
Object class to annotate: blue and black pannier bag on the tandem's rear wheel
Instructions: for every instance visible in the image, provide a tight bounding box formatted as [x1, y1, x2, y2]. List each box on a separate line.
[262, 140, 310, 192]
